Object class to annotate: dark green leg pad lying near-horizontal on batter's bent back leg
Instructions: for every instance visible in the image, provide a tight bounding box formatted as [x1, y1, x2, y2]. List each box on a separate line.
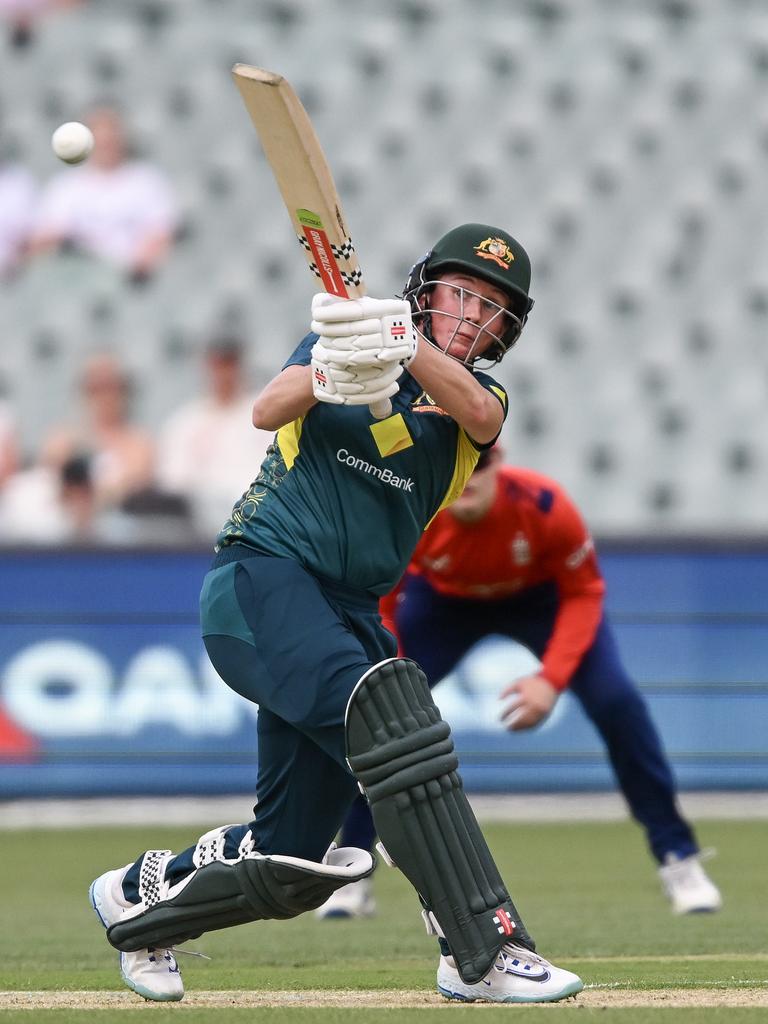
[106, 847, 374, 952]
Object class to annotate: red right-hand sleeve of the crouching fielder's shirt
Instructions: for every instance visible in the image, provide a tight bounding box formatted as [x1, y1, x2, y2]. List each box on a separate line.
[542, 490, 605, 689]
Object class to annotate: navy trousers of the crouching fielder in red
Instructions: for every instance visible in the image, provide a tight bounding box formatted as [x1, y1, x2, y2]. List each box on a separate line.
[342, 577, 698, 862]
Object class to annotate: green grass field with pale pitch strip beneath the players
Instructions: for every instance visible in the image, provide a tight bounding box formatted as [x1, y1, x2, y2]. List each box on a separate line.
[0, 821, 768, 1024]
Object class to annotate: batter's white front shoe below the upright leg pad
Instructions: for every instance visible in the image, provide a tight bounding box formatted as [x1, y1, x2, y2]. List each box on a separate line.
[437, 942, 584, 1002]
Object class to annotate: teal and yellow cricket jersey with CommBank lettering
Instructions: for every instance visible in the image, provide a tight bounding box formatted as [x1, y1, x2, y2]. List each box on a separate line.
[216, 334, 507, 596]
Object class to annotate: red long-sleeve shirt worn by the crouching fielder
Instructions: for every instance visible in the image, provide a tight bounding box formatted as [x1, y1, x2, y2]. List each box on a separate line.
[381, 466, 605, 689]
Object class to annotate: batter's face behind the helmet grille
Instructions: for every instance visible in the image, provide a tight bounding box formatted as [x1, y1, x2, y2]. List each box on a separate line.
[424, 271, 510, 362]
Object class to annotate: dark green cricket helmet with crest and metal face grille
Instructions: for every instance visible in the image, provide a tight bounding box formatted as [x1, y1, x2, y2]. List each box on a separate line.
[402, 224, 534, 364]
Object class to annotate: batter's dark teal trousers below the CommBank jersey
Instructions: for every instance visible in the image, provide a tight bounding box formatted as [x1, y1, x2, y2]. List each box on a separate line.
[123, 545, 397, 902]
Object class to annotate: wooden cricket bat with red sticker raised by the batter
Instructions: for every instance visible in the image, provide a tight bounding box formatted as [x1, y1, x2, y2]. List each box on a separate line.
[232, 63, 392, 420]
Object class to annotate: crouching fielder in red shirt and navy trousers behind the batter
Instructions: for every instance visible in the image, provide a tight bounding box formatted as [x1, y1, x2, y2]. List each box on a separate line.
[317, 446, 721, 916]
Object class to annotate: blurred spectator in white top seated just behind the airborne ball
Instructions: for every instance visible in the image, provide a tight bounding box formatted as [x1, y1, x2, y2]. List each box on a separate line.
[32, 106, 178, 282]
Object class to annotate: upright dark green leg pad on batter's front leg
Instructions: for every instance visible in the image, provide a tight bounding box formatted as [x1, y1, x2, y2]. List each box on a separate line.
[346, 658, 534, 984]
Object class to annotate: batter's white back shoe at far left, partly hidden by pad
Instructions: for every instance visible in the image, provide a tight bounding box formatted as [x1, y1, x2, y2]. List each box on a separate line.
[88, 864, 184, 1002]
